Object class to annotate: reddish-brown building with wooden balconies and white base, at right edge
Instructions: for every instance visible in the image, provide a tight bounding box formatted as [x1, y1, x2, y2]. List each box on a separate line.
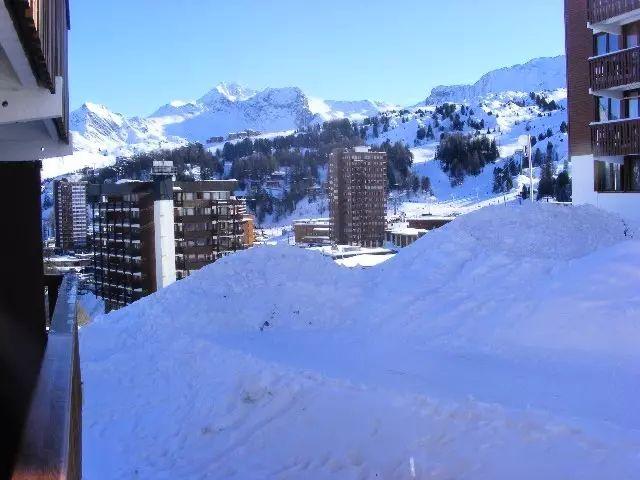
[565, 0, 640, 219]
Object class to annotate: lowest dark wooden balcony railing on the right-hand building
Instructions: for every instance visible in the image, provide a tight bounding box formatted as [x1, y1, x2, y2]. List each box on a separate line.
[591, 119, 640, 157]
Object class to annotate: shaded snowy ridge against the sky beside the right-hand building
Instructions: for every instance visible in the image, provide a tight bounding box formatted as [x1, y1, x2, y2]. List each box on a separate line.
[425, 55, 566, 105]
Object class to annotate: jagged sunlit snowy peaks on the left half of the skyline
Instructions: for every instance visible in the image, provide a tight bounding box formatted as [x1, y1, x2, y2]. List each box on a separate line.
[66, 83, 394, 158]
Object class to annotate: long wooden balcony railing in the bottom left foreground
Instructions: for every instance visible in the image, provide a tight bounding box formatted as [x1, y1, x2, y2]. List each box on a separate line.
[12, 275, 82, 480]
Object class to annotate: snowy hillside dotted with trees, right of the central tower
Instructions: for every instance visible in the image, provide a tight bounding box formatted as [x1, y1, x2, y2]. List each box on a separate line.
[252, 56, 568, 225]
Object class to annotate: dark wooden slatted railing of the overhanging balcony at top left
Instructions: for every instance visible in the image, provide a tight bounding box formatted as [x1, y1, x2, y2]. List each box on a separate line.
[5, 0, 69, 140]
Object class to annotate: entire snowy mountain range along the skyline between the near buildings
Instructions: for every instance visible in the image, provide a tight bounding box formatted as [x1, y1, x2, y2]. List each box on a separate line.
[44, 57, 566, 182]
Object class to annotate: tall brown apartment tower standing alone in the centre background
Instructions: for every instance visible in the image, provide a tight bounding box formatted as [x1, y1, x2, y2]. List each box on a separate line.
[329, 147, 387, 247]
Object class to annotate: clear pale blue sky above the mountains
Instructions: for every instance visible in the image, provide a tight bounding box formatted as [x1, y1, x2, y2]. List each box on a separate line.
[70, 0, 564, 116]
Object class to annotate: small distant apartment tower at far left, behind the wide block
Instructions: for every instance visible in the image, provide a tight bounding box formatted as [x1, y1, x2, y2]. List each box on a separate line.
[53, 180, 88, 252]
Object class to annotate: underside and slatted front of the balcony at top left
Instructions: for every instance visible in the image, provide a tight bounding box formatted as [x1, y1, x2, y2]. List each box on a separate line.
[0, 0, 72, 161]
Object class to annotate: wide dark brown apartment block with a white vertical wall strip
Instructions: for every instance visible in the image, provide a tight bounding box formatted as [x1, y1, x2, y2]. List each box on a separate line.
[87, 162, 246, 310]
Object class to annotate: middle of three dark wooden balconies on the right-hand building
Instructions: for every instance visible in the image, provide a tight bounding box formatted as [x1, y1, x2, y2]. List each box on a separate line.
[589, 46, 640, 96]
